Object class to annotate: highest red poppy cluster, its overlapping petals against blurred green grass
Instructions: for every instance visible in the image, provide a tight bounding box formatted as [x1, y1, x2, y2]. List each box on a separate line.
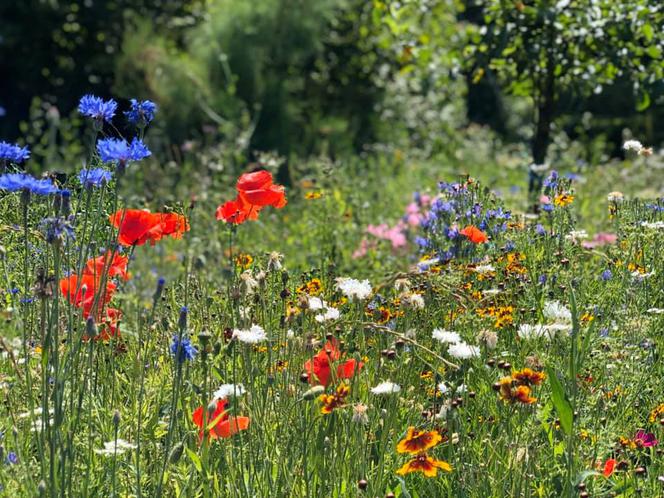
[215, 170, 287, 225]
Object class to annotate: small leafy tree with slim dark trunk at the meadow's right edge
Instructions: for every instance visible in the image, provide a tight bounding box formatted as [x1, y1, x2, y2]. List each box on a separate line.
[468, 0, 664, 198]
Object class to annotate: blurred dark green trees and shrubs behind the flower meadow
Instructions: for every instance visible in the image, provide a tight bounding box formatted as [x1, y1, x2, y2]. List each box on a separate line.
[0, 0, 664, 174]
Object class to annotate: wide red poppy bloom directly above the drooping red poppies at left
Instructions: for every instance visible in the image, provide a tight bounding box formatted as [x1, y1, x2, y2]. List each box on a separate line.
[110, 209, 189, 246]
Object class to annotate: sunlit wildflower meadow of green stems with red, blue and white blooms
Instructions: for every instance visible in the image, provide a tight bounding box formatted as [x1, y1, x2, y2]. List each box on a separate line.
[0, 104, 664, 498]
